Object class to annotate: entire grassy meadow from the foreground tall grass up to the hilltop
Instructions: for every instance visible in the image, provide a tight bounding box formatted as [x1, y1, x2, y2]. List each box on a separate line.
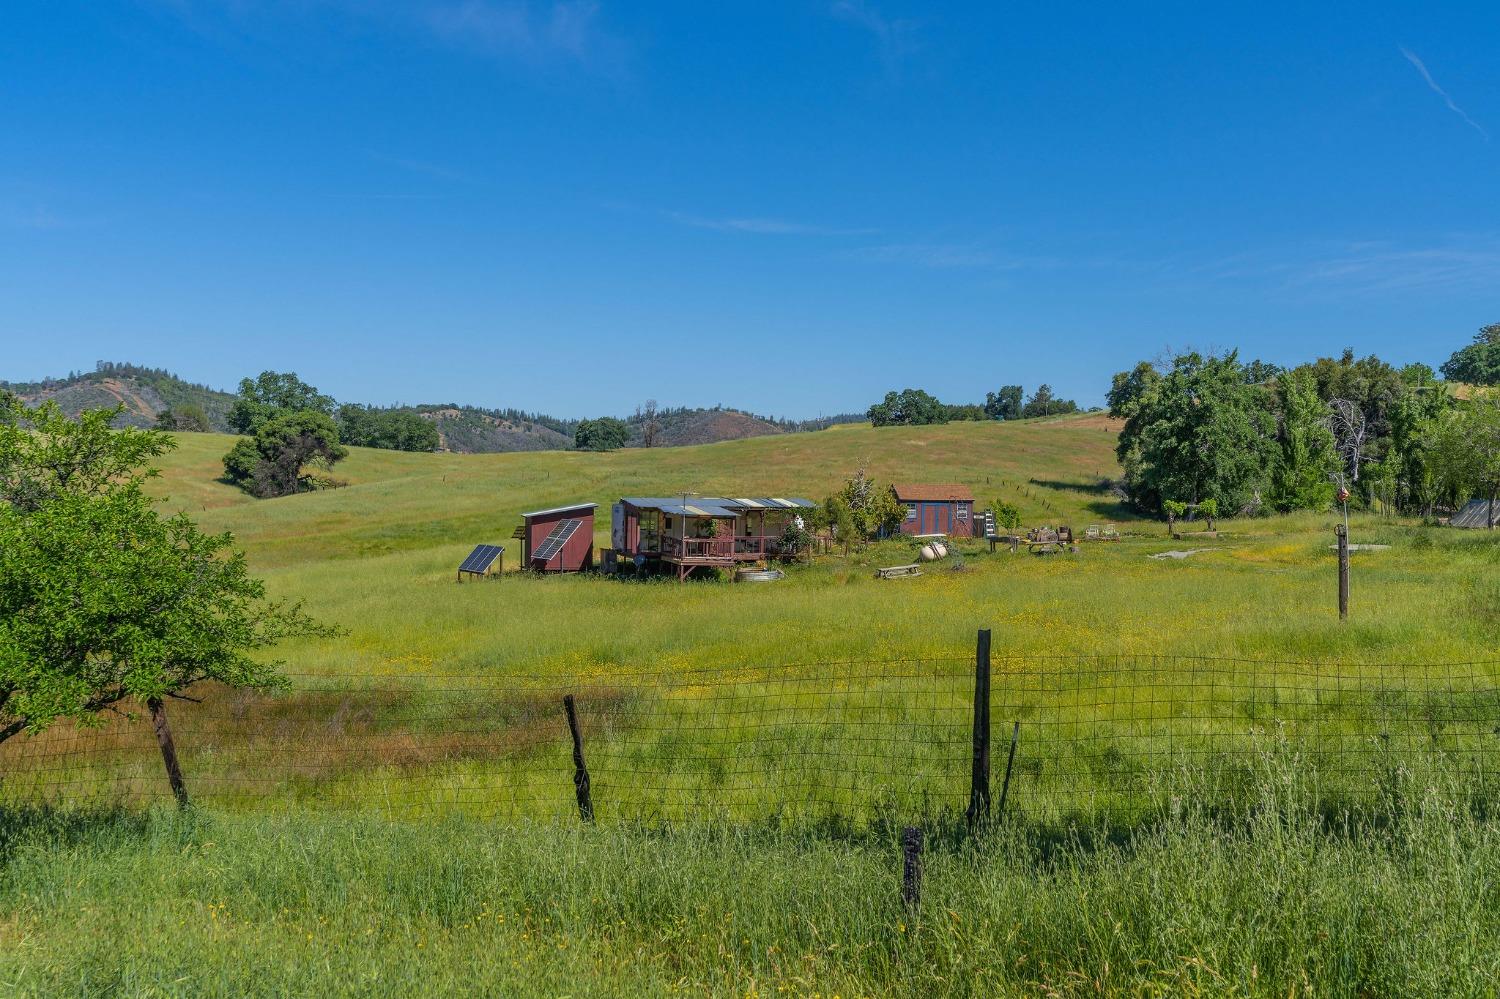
[0, 416, 1500, 996]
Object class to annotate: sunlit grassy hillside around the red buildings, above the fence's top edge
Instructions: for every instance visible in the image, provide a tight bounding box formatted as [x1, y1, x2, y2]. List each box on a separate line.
[156, 416, 1500, 675]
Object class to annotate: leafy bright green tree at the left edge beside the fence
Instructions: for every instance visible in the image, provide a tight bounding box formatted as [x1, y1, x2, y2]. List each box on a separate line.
[0, 402, 332, 797]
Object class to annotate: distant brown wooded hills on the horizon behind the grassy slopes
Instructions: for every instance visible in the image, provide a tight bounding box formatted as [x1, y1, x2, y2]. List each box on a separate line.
[0, 362, 864, 455]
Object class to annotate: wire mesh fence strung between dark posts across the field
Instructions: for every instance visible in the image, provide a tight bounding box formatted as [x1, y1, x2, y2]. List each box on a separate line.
[0, 642, 1500, 822]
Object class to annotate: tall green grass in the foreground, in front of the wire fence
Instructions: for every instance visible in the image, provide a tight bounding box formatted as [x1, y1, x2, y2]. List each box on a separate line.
[0, 746, 1500, 996]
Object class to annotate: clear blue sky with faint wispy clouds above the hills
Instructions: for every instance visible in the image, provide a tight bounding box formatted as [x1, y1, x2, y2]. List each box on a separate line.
[0, 0, 1500, 416]
